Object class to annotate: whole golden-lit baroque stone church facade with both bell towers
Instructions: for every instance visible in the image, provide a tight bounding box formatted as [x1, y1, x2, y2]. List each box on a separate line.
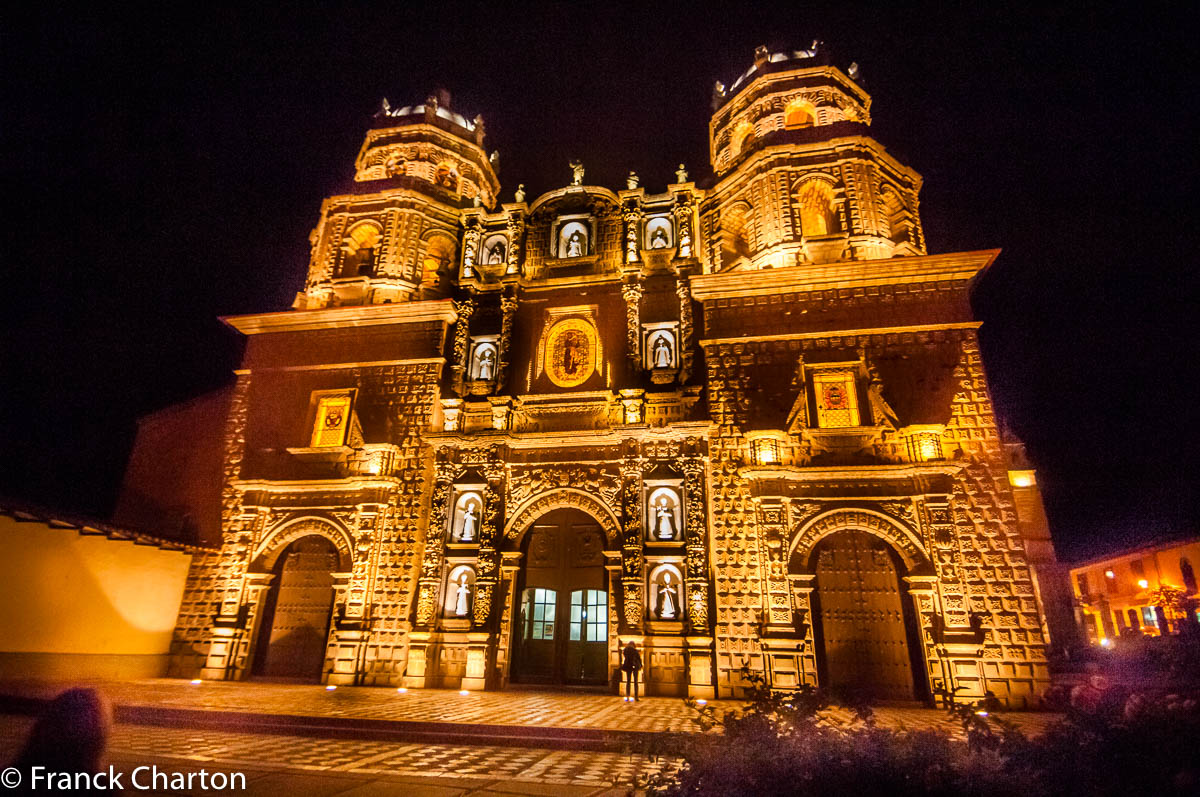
[154, 48, 1049, 705]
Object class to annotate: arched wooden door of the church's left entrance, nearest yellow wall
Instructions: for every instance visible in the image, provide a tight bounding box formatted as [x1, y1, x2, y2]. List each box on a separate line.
[253, 534, 338, 683]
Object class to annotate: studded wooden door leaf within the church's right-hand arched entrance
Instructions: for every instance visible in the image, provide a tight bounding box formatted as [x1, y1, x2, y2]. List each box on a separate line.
[816, 531, 914, 700]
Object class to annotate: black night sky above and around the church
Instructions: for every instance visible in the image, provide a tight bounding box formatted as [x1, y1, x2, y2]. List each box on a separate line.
[0, 2, 1200, 559]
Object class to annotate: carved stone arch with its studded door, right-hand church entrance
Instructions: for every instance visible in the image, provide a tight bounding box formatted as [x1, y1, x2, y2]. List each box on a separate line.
[791, 508, 929, 701]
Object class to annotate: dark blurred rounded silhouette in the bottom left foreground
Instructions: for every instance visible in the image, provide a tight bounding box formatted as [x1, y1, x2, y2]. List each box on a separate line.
[13, 688, 113, 778]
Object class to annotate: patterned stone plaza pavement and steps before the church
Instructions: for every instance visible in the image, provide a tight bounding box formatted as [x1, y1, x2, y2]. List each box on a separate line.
[0, 679, 1055, 797]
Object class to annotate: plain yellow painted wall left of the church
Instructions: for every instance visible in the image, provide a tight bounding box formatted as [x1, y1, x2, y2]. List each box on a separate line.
[0, 515, 192, 677]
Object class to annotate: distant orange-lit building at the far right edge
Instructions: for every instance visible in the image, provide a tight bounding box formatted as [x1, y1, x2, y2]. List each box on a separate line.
[1070, 538, 1200, 646]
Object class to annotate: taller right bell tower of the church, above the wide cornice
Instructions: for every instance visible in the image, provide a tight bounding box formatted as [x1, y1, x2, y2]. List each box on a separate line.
[703, 42, 925, 272]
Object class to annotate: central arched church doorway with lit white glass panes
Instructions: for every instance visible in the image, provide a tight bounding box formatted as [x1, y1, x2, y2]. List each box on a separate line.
[510, 509, 608, 684]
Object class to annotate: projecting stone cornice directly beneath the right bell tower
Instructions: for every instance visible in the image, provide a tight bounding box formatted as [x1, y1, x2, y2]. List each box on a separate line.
[690, 250, 1000, 301]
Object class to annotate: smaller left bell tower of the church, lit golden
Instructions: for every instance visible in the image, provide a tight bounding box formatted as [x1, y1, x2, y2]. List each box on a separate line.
[293, 91, 500, 310]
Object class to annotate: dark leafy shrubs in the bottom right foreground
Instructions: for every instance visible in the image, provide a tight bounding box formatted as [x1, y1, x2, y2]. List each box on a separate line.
[648, 672, 1200, 797]
